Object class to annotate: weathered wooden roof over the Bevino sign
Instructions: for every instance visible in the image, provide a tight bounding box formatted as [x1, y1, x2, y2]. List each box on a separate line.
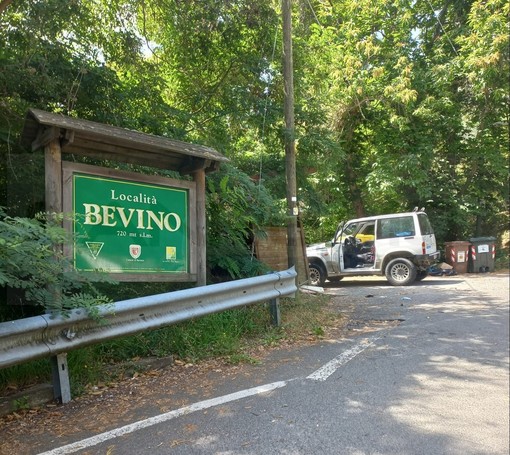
[21, 109, 228, 174]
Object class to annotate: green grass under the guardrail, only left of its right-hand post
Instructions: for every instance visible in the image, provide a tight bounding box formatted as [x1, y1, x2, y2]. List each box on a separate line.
[0, 304, 272, 395]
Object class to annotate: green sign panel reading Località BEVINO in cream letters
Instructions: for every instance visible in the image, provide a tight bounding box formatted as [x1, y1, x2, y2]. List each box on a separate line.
[71, 171, 190, 274]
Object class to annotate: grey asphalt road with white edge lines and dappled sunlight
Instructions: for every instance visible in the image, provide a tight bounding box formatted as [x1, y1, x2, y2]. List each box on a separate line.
[0, 274, 509, 455]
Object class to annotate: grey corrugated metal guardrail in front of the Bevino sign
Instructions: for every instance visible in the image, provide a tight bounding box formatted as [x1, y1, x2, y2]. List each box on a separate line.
[0, 268, 297, 403]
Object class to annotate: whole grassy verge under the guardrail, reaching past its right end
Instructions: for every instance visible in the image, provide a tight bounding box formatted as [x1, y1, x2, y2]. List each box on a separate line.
[0, 295, 339, 396]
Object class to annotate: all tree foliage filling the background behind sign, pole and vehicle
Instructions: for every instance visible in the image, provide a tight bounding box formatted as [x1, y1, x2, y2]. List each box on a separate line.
[0, 0, 510, 255]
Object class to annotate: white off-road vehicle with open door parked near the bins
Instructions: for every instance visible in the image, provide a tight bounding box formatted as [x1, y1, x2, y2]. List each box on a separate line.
[306, 211, 439, 286]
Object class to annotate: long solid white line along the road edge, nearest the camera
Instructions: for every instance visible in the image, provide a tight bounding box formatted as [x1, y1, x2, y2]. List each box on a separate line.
[39, 381, 288, 455]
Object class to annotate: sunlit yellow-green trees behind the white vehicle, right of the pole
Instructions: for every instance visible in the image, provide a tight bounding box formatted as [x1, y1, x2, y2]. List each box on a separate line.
[298, 0, 510, 244]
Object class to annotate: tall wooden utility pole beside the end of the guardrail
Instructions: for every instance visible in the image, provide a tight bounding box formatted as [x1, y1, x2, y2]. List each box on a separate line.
[282, 0, 298, 271]
